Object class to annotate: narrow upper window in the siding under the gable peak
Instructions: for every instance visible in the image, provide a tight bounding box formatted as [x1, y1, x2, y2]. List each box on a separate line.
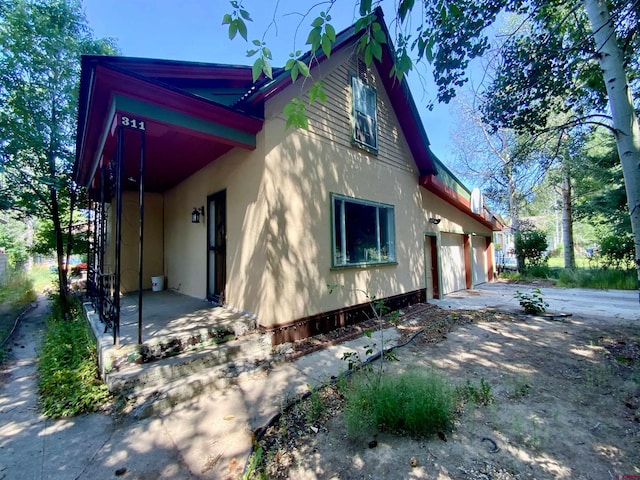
[351, 75, 378, 153]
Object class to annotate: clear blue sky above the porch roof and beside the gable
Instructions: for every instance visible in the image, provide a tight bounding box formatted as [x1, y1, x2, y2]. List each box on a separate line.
[83, 0, 454, 167]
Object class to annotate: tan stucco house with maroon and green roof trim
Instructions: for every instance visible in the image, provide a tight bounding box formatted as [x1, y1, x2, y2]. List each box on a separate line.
[75, 11, 500, 343]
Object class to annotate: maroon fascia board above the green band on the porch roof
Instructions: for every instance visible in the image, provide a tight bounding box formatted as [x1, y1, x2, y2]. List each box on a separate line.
[95, 65, 263, 134]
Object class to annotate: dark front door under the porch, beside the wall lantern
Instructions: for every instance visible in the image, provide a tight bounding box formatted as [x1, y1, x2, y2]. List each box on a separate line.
[207, 191, 227, 305]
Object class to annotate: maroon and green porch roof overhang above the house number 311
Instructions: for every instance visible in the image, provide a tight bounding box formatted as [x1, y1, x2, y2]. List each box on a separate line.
[74, 57, 263, 192]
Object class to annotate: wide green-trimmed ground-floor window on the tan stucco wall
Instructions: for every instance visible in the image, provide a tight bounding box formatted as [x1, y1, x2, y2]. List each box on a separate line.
[331, 195, 396, 267]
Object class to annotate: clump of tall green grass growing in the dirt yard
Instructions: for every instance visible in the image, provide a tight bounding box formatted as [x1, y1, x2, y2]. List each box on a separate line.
[344, 370, 455, 437]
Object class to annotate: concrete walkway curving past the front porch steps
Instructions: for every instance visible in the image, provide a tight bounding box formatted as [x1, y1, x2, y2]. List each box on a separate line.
[0, 298, 397, 480]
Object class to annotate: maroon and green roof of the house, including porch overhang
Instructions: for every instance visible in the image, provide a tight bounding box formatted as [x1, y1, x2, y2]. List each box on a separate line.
[74, 7, 499, 229]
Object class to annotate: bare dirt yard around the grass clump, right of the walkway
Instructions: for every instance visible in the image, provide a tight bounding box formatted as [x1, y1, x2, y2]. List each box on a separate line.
[252, 306, 640, 480]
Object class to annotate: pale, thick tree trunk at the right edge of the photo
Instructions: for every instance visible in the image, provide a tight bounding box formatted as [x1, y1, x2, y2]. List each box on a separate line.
[584, 0, 640, 300]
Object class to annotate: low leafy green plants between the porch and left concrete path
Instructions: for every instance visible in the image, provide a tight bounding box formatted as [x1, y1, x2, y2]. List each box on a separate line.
[38, 296, 109, 418]
